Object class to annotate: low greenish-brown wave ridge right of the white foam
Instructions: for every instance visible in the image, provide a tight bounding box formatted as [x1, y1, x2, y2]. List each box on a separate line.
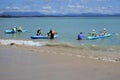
[45, 42, 120, 52]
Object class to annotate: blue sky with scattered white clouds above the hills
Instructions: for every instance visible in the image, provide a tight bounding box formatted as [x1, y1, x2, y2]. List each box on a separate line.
[0, 0, 120, 14]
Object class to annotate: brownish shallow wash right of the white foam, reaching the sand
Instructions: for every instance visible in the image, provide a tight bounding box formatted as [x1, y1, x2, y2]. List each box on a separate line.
[46, 43, 120, 62]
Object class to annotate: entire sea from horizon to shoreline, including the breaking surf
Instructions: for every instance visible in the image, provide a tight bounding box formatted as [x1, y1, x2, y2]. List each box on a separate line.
[0, 17, 120, 62]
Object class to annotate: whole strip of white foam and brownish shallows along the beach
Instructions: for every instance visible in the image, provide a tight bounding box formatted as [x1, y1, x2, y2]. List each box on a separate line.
[0, 39, 120, 62]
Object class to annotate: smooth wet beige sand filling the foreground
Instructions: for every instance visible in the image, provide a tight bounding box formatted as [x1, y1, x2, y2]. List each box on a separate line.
[0, 45, 120, 80]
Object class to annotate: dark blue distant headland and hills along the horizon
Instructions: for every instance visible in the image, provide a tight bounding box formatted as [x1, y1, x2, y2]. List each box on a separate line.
[0, 12, 120, 18]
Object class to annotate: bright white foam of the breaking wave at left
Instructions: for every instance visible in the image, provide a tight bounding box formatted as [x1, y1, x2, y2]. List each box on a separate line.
[0, 39, 44, 46]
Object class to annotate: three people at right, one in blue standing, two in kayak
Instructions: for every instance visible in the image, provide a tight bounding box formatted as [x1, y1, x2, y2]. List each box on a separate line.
[77, 28, 107, 40]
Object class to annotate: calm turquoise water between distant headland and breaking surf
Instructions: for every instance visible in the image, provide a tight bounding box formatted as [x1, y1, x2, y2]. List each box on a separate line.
[0, 17, 120, 45]
